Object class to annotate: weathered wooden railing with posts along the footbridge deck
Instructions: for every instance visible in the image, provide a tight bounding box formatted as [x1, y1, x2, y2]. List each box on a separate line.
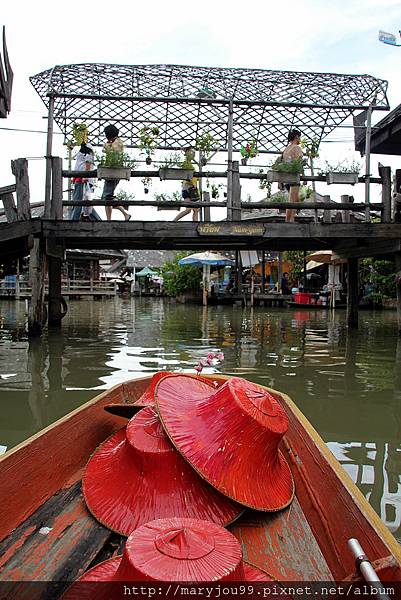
[0, 157, 401, 223]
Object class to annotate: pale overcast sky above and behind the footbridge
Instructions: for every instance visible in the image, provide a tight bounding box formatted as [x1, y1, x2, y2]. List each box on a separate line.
[0, 0, 401, 219]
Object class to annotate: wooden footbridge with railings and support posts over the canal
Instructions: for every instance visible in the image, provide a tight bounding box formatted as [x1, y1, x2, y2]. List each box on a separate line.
[0, 158, 401, 334]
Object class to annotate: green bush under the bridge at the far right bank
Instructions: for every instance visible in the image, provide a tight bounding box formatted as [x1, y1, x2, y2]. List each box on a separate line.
[359, 258, 397, 304]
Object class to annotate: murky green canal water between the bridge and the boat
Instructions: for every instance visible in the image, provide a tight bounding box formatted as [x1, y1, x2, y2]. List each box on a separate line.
[0, 298, 401, 541]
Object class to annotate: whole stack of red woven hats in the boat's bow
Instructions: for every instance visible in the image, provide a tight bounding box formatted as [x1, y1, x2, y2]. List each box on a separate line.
[74, 373, 294, 582]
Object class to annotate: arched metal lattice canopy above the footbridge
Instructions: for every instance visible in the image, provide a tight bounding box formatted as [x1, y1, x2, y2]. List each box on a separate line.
[30, 64, 389, 152]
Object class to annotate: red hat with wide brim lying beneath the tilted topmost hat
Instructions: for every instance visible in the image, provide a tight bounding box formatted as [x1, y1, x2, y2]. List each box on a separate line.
[82, 407, 243, 536]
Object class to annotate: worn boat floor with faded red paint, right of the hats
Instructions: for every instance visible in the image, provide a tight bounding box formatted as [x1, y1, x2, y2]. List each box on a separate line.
[230, 498, 333, 581]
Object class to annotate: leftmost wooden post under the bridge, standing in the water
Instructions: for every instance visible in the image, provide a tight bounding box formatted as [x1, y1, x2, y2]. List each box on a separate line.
[28, 238, 46, 337]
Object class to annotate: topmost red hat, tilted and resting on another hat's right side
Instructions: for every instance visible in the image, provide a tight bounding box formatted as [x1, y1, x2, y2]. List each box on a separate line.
[155, 375, 294, 511]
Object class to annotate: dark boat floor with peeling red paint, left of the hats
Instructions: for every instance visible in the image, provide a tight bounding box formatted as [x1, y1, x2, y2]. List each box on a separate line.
[0, 482, 115, 600]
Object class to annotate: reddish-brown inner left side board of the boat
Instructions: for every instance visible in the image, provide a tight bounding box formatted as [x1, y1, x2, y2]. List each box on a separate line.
[0, 385, 131, 540]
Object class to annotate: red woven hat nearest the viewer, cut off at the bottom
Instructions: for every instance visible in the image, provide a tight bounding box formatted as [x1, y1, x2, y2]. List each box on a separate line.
[63, 518, 274, 600]
